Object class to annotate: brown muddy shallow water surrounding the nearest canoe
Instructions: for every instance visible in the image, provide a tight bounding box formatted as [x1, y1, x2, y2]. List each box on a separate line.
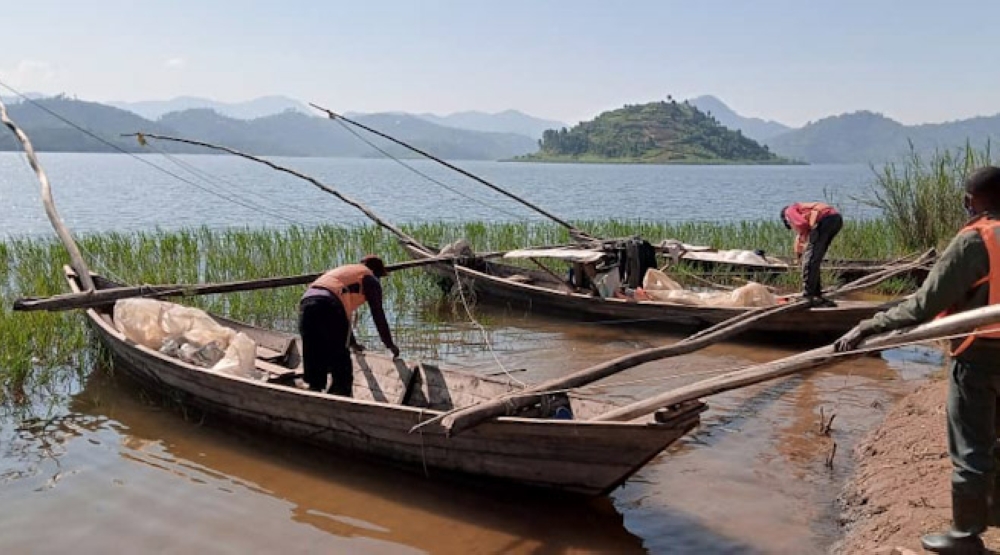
[0, 313, 939, 554]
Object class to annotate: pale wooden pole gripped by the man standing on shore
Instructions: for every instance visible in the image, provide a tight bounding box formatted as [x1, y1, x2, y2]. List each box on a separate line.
[593, 305, 1000, 421]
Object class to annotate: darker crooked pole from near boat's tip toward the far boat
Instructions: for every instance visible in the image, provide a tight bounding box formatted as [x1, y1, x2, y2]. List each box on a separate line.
[413, 254, 919, 435]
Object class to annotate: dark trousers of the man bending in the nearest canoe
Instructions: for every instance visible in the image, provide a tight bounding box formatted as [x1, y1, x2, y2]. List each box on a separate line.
[299, 297, 354, 397]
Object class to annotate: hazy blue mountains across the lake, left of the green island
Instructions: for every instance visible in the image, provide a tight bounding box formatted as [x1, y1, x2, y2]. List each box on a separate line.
[0, 97, 538, 160]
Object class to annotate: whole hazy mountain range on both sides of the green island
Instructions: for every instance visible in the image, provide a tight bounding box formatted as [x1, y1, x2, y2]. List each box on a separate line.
[0, 93, 1000, 164]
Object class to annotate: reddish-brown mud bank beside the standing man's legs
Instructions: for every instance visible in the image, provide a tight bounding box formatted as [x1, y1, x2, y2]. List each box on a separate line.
[833, 376, 1000, 555]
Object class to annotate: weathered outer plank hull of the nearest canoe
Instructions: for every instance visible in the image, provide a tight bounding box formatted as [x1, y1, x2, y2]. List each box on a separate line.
[71, 270, 704, 496]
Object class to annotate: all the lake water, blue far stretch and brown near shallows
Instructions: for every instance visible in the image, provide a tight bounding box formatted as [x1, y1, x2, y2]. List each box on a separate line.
[0, 154, 939, 554]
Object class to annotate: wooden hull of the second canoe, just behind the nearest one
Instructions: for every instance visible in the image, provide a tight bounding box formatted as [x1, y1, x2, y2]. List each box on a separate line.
[402, 243, 892, 341]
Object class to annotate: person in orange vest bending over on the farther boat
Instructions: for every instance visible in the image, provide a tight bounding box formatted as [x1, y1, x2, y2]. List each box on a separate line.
[781, 202, 844, 307]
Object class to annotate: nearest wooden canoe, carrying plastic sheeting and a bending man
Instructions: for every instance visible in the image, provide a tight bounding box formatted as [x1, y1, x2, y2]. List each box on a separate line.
[66, 268, 705, 495]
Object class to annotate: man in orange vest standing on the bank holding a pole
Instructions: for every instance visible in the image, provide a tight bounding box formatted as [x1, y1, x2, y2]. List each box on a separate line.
[835, 166, 1000, 554]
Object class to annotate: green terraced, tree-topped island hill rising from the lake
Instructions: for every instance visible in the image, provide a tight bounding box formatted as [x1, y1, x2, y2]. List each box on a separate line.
[516, 97, 789, 164]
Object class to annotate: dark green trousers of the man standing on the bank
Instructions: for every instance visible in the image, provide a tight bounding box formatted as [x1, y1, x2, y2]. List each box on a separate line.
[948, 359, 1000, 534]
